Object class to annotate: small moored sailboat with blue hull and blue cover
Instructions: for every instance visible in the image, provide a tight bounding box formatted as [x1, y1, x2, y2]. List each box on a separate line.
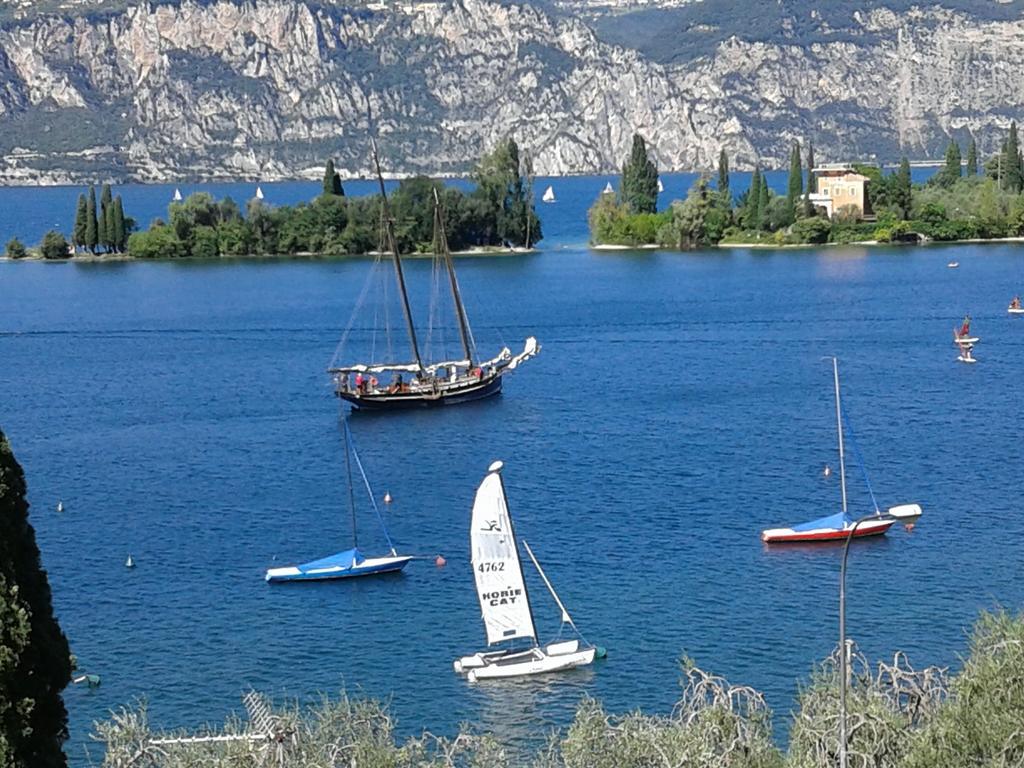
[266, 421, 413, 584]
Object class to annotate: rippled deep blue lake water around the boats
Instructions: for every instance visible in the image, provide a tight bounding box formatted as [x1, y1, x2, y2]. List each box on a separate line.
[0, 177, 1024, 765]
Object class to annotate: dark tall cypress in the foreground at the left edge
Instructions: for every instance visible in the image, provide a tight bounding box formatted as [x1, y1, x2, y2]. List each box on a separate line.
[0, 431, 72, 768]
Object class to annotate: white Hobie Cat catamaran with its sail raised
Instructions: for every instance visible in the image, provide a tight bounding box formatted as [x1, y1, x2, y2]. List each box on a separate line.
[455, 462, 603, 682]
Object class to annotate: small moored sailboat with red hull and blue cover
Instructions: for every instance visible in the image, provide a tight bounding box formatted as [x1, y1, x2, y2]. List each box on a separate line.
[761, 357, 921, 544]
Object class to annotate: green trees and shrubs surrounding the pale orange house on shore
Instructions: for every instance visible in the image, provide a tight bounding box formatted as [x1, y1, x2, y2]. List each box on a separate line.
[588, 122, 1024, 249]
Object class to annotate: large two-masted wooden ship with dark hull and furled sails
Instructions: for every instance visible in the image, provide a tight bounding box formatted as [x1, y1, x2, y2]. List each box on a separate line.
[328, 147, 541, 411]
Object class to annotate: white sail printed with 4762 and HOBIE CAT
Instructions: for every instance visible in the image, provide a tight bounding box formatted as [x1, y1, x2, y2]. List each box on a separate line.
[470, 462, 537, 645]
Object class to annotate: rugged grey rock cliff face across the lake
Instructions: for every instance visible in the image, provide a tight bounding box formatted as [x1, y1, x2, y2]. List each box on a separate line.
[0, 0, 1024, 182]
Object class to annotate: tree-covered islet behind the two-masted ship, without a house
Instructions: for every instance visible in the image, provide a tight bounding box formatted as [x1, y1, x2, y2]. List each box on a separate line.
[6, 139, 544, 259]
